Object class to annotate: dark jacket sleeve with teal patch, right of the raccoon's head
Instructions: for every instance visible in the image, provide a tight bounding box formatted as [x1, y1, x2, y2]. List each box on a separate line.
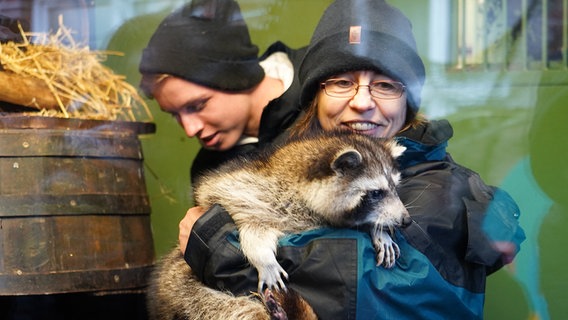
[398, 157, 524, 292]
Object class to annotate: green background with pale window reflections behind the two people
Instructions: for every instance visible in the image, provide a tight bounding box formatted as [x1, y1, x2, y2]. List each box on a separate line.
[0, 0, 568, 319]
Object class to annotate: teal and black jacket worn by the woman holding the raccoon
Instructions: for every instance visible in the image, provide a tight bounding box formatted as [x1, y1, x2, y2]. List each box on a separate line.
[185, 121, 525, 319]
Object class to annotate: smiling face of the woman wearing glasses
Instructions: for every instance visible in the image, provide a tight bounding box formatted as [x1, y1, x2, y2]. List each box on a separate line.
[316, 71, 406, 138]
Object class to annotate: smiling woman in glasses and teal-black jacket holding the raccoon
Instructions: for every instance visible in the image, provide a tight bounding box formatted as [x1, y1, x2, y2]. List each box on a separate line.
[154, 0, 524, 319]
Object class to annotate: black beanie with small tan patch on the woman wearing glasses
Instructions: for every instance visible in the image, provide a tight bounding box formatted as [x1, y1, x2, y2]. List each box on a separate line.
[299, 0, 425, 112]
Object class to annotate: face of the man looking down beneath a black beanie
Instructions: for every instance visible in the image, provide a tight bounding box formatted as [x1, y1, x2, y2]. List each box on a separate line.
[153, 77, 250, 150]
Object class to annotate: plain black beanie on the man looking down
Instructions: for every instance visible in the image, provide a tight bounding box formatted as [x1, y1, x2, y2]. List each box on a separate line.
[139, 0, 264, 91]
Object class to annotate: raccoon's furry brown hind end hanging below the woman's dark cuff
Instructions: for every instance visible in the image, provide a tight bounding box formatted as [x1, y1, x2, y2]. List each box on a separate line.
[147, 248, 270, 320]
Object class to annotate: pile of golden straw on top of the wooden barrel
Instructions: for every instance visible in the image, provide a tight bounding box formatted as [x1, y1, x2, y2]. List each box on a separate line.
[0, 16, 153, 121]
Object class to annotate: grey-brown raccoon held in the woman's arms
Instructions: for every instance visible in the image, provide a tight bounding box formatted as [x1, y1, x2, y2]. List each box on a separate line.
[149, 132, 410, 319]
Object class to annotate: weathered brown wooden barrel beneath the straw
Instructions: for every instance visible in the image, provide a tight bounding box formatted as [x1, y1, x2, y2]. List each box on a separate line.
[0, 115, 155, 295]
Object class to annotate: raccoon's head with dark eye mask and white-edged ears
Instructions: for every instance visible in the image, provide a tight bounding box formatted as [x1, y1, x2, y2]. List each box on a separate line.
[305, 140, 410, 227]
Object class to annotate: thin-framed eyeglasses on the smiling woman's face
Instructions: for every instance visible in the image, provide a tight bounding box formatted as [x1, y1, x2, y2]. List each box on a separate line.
[321, 79, 406, 99]
